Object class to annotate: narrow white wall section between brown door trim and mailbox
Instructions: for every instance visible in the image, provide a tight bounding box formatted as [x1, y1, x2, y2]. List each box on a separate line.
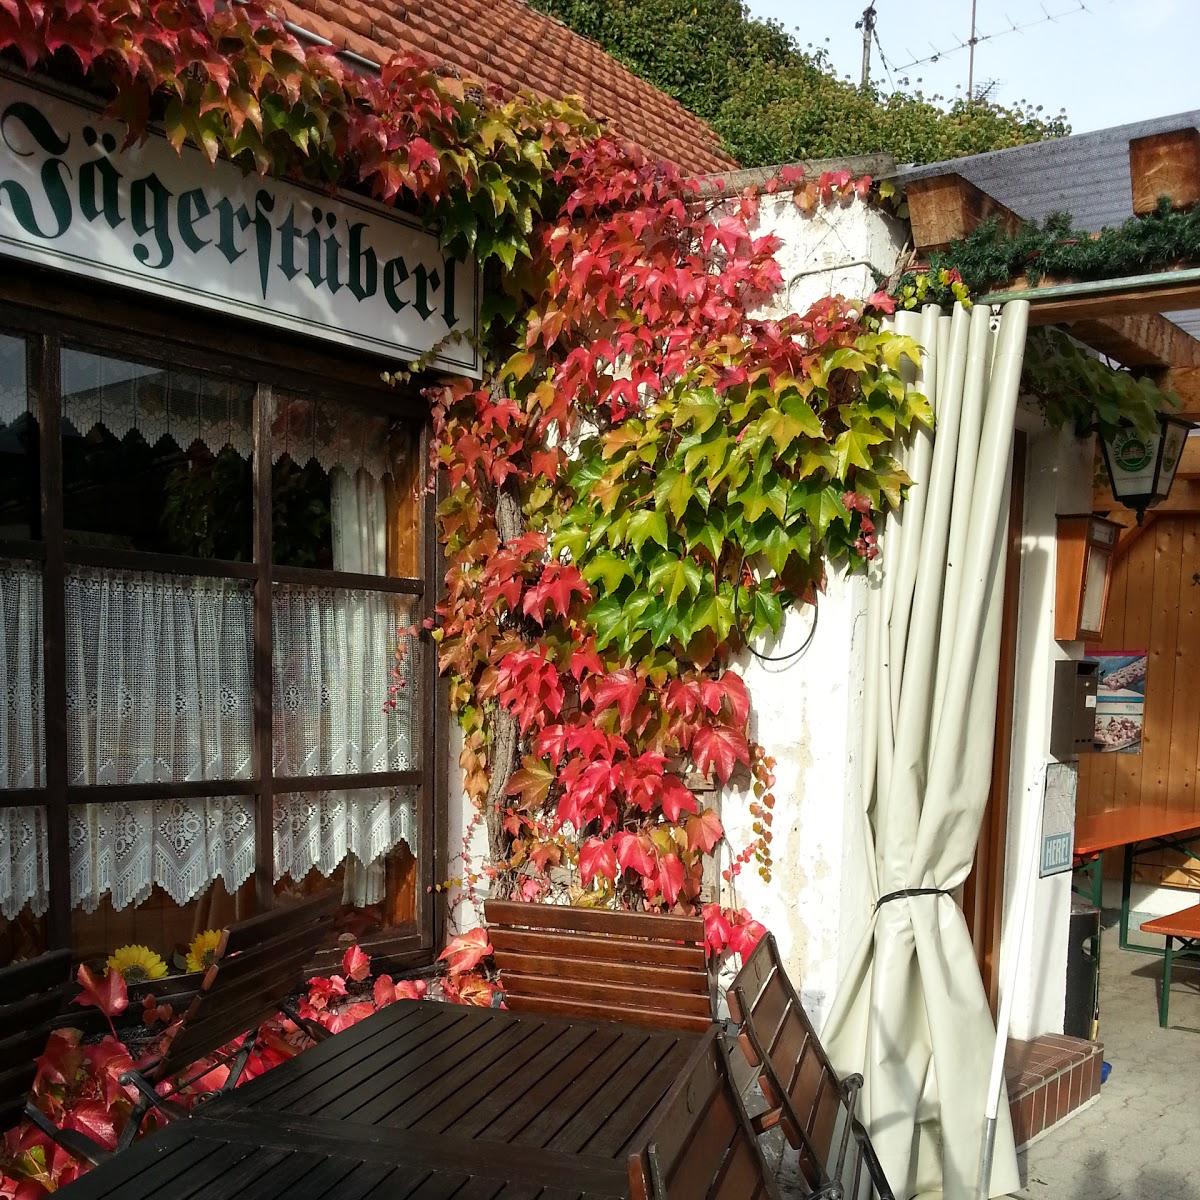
[1001, 408, 1092, 1038]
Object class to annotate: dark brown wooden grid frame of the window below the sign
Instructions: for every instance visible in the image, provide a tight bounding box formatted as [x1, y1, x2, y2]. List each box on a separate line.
[0, 276, 449, 967]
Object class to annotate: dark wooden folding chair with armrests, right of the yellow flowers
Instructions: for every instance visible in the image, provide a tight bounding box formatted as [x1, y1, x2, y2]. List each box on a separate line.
[121, 890, 338, 1148]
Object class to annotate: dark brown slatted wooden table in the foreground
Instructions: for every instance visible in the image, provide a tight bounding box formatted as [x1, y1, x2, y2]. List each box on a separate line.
[63, 1001, 712, 1200]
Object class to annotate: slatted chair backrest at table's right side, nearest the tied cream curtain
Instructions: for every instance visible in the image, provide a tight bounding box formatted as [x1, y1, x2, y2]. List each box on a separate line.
[726, 934, 894, 1200]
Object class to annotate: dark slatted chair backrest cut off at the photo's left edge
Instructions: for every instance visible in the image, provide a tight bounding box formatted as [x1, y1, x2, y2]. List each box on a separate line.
[0, 950, 71, 1129]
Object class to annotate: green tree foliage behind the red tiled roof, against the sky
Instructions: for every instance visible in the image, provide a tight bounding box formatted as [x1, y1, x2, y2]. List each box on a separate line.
[533, 0, 1069, 167]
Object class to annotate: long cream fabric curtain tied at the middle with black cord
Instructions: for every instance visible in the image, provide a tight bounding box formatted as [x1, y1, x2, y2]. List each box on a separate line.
[824, 301, 1028, 1200]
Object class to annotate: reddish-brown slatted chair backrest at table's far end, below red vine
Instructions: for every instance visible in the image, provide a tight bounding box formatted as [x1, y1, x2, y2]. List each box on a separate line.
[485, 900, 713, 1031]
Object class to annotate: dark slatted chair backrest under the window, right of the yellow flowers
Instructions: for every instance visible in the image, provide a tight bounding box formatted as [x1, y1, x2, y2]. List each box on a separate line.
[151, 889, 338, 1080]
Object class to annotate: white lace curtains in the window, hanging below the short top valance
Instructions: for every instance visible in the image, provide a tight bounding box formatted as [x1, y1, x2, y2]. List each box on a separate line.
[0, 468, 419, 917]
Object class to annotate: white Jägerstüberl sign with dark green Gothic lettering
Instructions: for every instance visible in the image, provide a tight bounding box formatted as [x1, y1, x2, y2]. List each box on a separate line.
[0, 76, 480, 376]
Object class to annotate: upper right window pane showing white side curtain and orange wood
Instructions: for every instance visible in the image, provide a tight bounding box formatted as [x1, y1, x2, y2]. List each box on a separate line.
[271, 394, 420, 576]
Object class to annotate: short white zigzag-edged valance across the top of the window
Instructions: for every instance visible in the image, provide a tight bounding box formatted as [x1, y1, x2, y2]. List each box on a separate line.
[58, 349, 391, 480]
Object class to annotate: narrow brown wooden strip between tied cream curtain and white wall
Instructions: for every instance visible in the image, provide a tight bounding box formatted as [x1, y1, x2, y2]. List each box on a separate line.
[962, 431, 1026, 1015]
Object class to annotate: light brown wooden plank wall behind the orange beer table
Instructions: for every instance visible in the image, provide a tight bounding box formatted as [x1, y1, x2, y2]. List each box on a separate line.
[1079, 516, 1200, 887]
